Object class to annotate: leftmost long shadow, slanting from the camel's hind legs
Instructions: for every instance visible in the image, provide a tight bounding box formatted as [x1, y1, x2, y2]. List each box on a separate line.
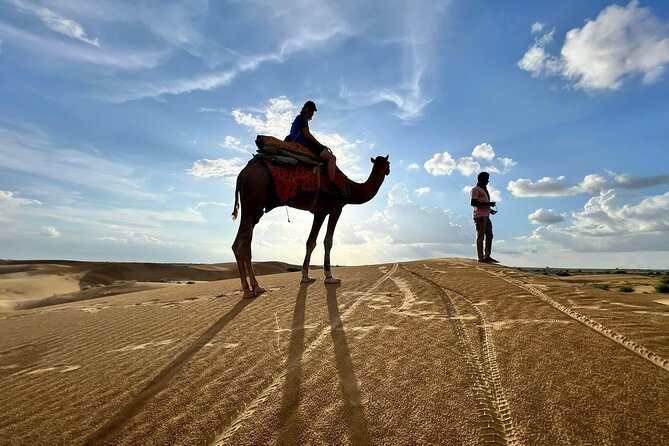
[86, 299, 255, 445]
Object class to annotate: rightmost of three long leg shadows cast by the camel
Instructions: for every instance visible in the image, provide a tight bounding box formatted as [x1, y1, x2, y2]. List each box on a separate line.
[327, 285, 372, 445]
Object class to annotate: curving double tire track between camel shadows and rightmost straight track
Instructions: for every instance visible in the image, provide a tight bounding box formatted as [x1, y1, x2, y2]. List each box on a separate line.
[402, 266, 522, 446]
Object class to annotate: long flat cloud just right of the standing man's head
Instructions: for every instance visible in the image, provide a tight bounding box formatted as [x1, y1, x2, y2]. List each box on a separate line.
[507, 174, 610, 197]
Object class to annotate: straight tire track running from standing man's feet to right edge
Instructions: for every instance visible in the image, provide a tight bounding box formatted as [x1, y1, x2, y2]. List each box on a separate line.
[475, 266, 669, 372]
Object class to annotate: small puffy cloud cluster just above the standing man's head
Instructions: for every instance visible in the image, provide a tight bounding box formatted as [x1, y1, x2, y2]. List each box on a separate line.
[423, 143, 517, 176]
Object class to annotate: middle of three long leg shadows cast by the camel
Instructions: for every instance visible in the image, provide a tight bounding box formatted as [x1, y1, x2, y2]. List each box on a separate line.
[277, 283, 309, 445]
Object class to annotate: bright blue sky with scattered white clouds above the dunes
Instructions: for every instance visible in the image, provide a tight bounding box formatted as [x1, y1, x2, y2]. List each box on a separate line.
[0, 0, 669, 268]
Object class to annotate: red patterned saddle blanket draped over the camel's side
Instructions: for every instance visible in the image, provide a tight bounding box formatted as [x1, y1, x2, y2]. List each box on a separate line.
[258, 159, 349, 212]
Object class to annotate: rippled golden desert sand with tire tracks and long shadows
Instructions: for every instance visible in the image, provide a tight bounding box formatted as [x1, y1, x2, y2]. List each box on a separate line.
[0, 258, 669, 445]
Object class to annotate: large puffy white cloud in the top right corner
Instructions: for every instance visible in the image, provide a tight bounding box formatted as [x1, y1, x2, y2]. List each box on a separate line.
[518, 0, 669, 91]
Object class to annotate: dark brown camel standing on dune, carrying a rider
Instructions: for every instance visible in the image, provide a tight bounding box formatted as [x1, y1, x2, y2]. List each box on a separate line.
[232, 156, 390, 299]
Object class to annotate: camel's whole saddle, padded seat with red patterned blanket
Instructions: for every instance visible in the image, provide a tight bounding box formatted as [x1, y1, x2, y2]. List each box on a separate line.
[252, 135, 349, 212]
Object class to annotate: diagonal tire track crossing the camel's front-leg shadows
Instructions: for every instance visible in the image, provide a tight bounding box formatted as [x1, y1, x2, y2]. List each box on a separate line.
[210, 263, 399, 446]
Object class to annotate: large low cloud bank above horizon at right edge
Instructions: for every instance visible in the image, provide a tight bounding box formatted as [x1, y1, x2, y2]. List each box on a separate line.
[532, 190, 669, 252]
